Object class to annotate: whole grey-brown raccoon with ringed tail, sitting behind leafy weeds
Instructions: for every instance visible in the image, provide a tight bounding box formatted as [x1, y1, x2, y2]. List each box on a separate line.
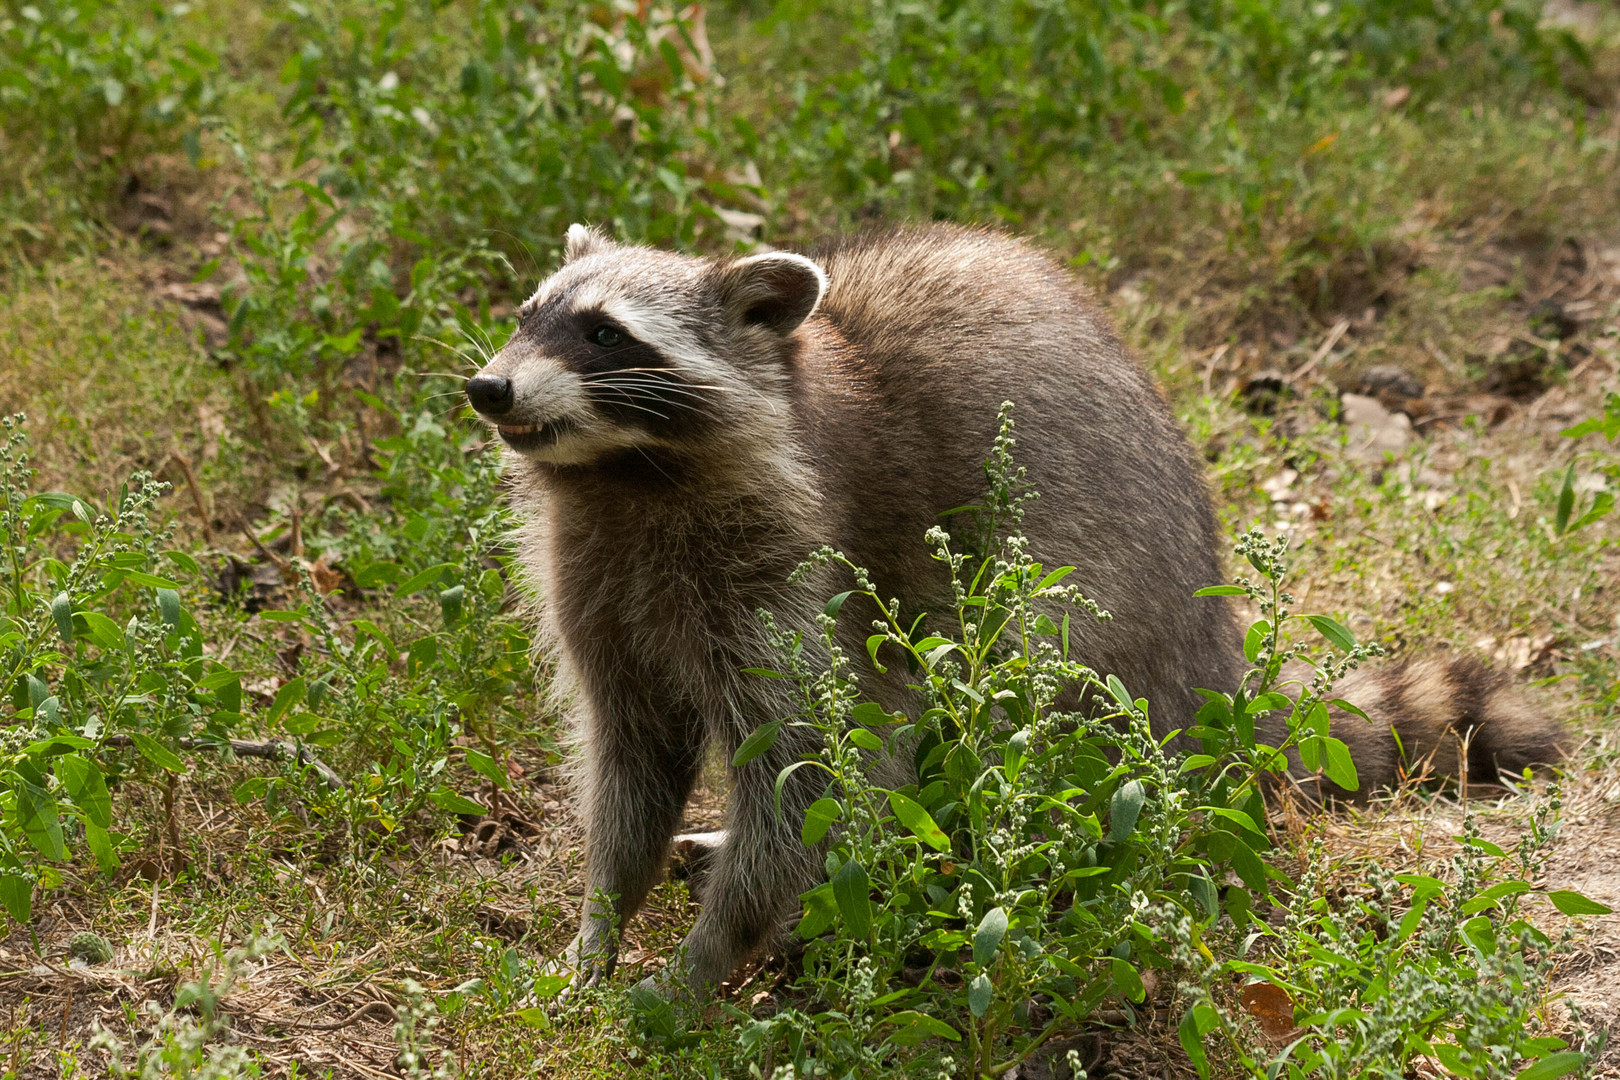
[467, 225, 1560, 996]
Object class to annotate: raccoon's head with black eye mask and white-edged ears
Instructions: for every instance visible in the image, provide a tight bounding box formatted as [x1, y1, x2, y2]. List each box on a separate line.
[467, 225, 826, 466]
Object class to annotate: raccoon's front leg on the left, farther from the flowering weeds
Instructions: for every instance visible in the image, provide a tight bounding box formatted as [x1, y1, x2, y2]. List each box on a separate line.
[564, 717, 701, 984]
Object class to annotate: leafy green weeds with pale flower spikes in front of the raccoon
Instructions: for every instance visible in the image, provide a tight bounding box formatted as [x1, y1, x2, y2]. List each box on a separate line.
[664, 415, 1607, 1077]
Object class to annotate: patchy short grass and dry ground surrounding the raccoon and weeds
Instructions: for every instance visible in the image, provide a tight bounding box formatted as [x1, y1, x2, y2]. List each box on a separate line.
[0, 0, 1620, 1077]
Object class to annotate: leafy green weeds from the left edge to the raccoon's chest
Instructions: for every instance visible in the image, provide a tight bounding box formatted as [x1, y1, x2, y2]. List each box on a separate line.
[0, 403, 531, 921]
